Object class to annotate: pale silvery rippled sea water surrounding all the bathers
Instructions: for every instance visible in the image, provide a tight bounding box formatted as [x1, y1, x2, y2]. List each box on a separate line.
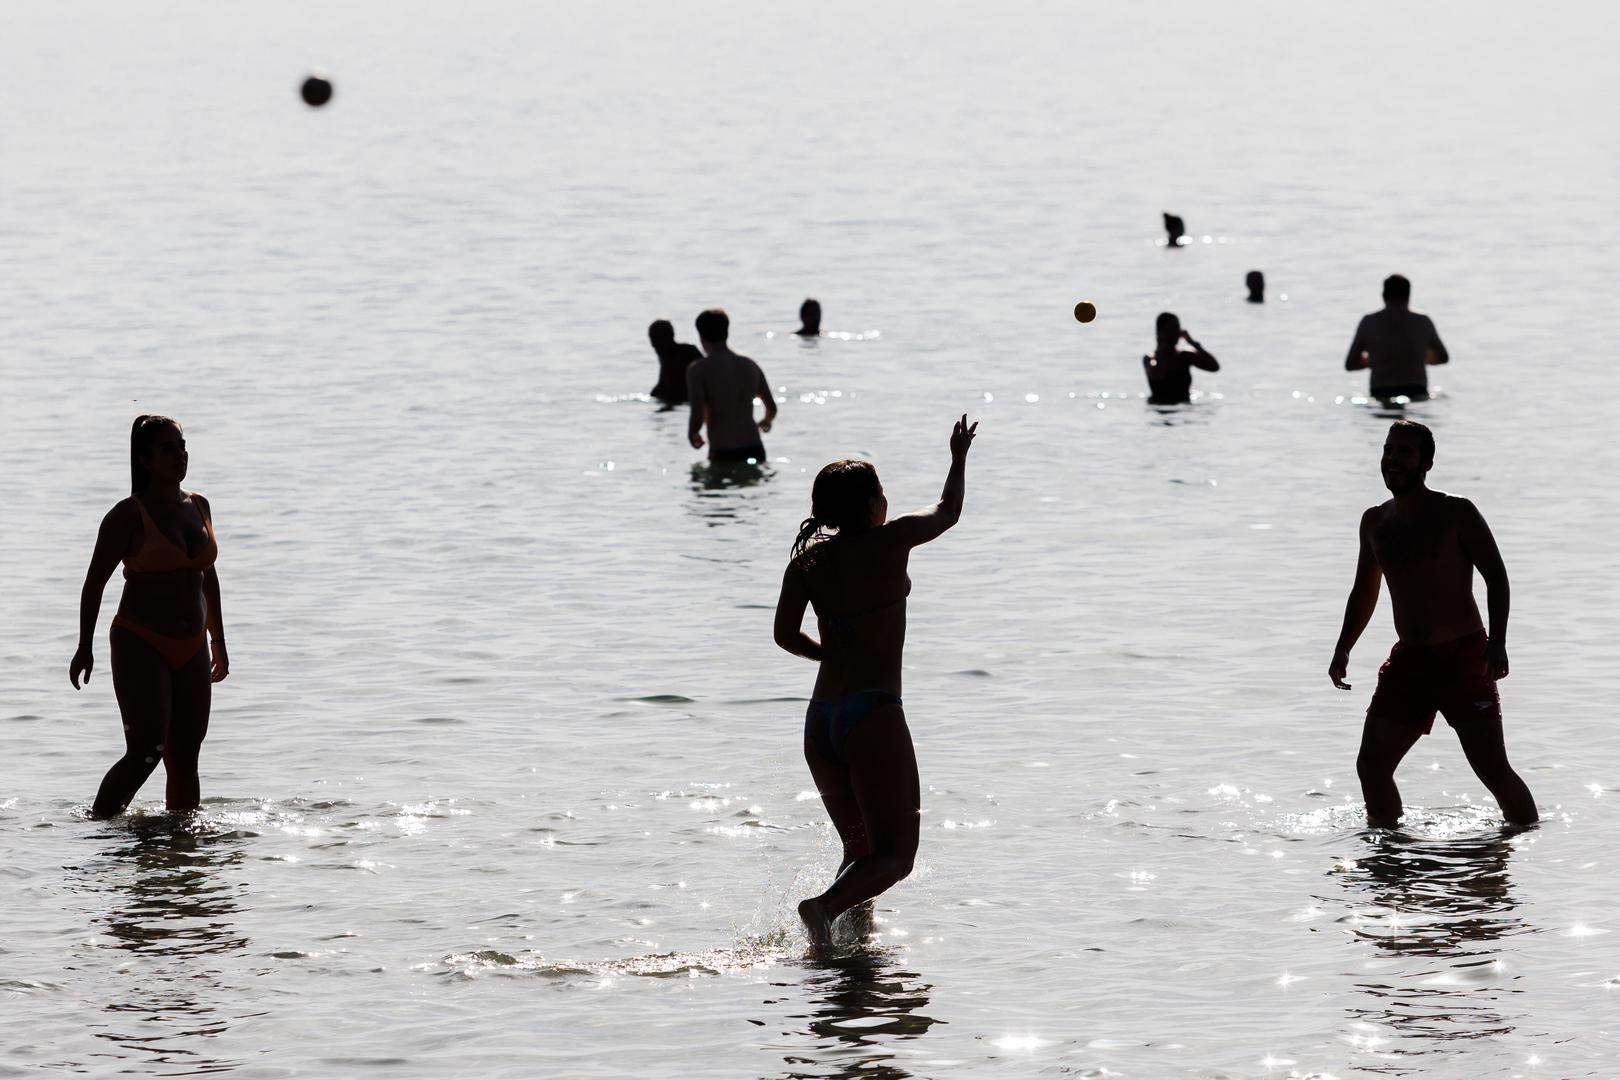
[0, 3, 1620, 1078]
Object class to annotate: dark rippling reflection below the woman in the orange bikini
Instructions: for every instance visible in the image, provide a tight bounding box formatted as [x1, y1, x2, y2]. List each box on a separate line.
[68, 814, 248, 1074]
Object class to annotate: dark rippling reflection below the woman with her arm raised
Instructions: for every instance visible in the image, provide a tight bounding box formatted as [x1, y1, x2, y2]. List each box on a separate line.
[778, 949, 941, 1080]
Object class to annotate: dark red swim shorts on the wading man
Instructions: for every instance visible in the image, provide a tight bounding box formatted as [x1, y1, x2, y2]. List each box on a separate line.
[1367, 630, 1502, 735]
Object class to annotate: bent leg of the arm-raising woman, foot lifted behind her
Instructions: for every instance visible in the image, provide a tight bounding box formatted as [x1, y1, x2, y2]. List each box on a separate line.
[799, 704, 922, 944]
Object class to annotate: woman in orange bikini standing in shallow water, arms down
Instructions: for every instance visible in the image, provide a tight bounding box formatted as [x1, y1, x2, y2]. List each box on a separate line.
[68, 416, 230, 818]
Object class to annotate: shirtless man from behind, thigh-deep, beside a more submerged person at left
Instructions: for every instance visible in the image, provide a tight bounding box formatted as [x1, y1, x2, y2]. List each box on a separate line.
[687, 308, 776, 461]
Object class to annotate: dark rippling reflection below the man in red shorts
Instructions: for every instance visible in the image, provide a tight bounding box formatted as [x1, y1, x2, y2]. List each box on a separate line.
[1337, 831, 1536, 1059]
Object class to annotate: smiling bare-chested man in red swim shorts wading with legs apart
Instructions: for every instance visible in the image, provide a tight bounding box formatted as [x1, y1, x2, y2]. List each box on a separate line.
[1327, 419, 1537, 827]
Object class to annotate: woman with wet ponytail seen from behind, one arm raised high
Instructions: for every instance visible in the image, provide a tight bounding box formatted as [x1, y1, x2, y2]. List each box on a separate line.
[776, 415, 978, 949]
